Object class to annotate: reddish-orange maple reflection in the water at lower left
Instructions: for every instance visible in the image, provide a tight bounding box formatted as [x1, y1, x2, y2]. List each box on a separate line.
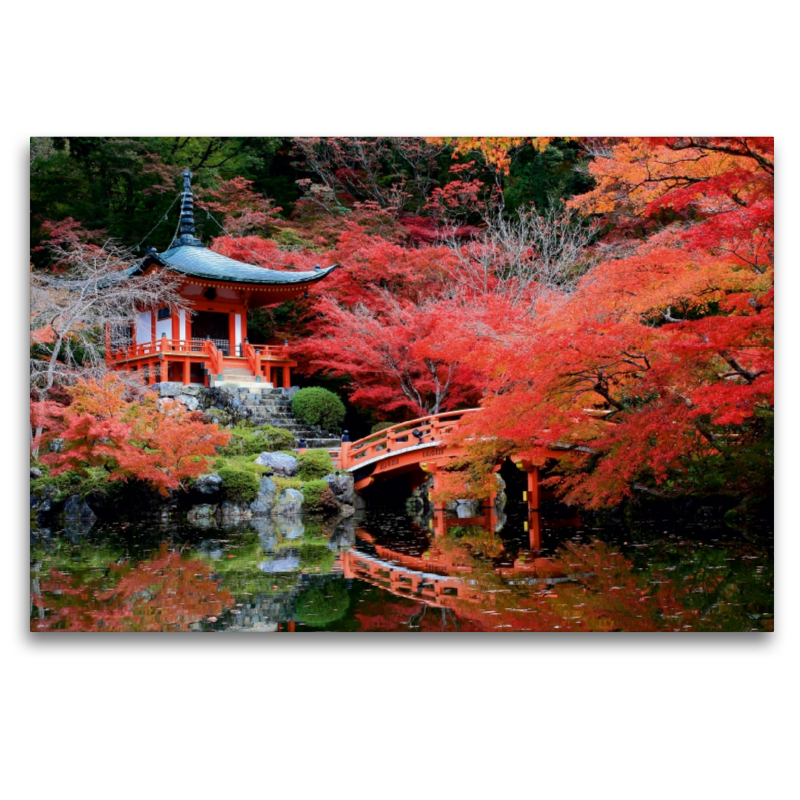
[31, 544, 234, 632]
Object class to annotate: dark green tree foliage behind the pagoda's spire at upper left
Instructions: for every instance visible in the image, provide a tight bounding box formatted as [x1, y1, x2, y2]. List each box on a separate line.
[31, 136, 288, 250]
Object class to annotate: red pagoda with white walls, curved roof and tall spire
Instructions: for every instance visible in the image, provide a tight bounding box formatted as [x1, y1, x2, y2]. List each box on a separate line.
[106, 169, 337, 388]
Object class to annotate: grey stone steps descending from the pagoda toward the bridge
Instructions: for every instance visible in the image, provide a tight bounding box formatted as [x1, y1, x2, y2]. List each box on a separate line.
[215, 376, 342, 450]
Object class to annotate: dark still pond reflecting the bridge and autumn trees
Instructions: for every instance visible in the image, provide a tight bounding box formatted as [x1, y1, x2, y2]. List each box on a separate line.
[30, 505, 774, 633]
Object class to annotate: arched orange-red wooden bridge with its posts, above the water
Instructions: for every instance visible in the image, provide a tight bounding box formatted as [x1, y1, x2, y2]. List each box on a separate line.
[335, 408, 559, 510]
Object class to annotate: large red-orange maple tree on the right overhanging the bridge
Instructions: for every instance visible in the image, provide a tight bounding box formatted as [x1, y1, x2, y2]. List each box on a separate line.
[446, 138, 774, 507]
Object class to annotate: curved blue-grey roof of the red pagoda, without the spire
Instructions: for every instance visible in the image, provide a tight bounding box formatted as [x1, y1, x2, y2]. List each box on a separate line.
[149, 244, 338, 286]
